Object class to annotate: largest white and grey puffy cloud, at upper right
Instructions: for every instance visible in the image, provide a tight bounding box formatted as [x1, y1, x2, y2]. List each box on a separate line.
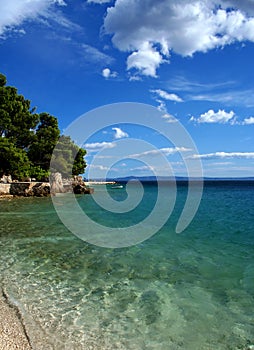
[104, 0, 254, 77]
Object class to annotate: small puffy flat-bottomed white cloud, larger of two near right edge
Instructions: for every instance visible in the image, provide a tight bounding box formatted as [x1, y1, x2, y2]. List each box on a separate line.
[190, 109, 235, 124]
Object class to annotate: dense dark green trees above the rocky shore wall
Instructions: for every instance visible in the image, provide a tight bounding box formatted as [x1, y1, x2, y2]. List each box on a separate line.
[0, 74, 86, 180]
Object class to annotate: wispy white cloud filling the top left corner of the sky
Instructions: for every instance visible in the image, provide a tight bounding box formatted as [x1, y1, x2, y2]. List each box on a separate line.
[0, 0, 66, 35]
